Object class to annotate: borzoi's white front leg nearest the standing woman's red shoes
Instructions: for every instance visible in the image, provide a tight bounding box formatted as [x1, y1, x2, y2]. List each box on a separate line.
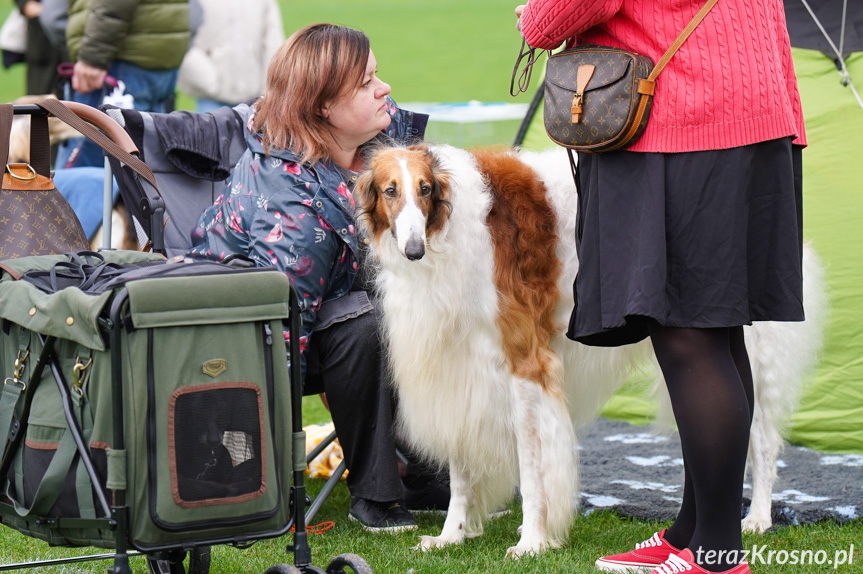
[506, 379, 548, 558]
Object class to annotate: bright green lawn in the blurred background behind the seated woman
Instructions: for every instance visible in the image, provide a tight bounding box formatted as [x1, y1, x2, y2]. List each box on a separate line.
[0, 0, 529, 108]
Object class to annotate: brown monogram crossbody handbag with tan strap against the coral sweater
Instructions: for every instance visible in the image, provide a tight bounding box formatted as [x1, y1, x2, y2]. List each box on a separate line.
[510, 0, 718, 157]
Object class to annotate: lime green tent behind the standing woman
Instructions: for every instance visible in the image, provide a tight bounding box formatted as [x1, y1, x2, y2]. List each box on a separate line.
[516, 0, 863, 460]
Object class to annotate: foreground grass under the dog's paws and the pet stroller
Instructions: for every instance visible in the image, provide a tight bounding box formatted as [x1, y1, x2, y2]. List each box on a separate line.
[0, 397, 863, 574]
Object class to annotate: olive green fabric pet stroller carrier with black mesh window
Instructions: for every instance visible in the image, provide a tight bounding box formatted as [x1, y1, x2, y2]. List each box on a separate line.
[0, 252, 292, 551]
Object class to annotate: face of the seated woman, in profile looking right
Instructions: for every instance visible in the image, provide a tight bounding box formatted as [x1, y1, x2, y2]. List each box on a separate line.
[323, 50, 391, 148]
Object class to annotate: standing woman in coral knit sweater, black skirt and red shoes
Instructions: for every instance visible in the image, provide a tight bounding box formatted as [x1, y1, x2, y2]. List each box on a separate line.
[516, 0, 805, 574]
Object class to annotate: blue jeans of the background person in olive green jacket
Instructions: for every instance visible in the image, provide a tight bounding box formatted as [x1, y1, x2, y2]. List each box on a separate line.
[55, 60, 178, 169]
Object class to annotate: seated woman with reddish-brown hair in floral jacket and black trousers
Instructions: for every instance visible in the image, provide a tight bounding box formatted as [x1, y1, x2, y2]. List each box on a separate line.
[190, 24, 427, 531]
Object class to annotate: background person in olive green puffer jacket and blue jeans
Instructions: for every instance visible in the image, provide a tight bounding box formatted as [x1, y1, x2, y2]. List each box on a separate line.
[57, 0, 191, 169]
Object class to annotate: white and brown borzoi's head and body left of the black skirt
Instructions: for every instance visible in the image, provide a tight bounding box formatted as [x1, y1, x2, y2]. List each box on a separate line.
[354, 145, 828, 556]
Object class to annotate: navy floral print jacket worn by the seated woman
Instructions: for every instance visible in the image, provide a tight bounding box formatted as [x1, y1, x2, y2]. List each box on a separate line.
[189, 100, 427, 363]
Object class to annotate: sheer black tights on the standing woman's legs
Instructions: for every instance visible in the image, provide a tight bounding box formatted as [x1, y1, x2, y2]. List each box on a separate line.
[650, 323, 754, 572]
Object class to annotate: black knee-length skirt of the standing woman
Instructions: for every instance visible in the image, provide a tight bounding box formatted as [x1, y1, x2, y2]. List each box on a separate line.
[567, 138, 803, 346]
